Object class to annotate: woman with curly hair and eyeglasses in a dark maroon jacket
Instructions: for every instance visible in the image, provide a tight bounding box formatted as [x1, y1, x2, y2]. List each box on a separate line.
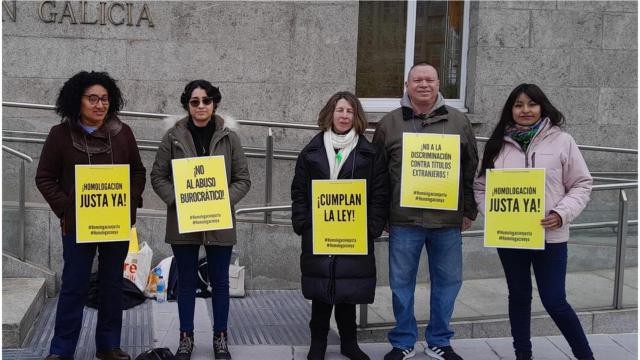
[36, 71, 145, 360]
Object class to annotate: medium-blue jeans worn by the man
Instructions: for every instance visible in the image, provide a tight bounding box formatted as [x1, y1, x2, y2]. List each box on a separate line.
[389, 226, 462, 349]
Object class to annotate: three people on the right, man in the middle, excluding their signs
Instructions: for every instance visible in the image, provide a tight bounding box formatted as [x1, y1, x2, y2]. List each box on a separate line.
[291, 63, 593, 360]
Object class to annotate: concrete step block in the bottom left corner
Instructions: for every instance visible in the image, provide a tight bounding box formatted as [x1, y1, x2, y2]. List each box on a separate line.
[2, 277, 46, 349]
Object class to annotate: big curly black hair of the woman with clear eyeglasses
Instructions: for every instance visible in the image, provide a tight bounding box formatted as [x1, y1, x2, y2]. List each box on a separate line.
[56, 71, 124, 123]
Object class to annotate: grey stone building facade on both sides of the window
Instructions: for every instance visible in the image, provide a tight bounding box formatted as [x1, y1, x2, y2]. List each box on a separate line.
[2, 1, 638, 287]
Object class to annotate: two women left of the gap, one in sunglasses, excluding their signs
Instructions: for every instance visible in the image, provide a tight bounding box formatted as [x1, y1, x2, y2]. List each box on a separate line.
[36, 71, 251, 360]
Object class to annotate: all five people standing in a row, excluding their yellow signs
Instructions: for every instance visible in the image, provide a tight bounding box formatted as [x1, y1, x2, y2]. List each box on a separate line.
[36, 63, 593, 360]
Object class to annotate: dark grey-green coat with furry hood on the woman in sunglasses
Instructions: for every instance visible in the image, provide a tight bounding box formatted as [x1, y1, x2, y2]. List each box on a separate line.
[151, 115, 251, 246]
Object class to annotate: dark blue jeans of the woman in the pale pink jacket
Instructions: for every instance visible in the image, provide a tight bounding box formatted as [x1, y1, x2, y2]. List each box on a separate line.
[498, 242, 593, 359]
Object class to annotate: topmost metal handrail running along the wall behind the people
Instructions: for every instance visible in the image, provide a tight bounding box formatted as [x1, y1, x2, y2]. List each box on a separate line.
[2, 101, 638, 155]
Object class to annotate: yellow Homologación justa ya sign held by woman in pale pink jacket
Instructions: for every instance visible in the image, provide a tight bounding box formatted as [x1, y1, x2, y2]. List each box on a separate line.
[484, 169, 545, 250]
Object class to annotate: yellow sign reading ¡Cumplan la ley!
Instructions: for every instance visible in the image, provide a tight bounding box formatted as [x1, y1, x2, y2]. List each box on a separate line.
[311, 179, 369, 255]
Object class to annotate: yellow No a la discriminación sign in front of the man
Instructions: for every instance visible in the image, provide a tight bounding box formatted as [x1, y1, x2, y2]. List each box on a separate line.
[400, 133, 460, 210]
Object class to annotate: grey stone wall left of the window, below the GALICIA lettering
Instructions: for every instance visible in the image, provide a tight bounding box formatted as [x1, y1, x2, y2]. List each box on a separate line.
[2, 1, 358, 209]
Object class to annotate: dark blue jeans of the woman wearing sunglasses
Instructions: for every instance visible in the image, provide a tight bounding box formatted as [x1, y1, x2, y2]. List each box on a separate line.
[171, 245, 233, 333]
